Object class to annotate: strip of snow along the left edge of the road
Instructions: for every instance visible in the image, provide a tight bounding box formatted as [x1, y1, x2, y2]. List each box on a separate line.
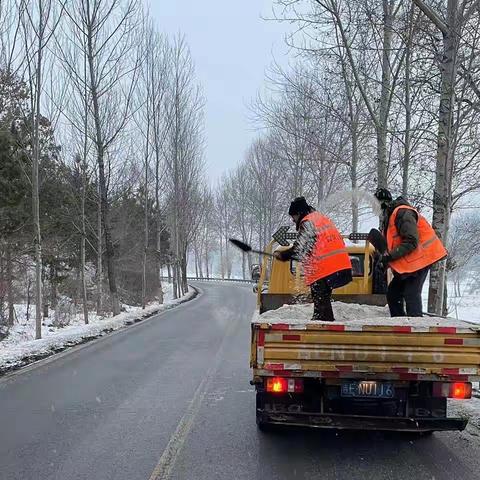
[0, 285, 196, 374]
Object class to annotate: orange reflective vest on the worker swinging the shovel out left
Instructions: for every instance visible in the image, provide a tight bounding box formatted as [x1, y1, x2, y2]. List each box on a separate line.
[302, 212, 352, 285]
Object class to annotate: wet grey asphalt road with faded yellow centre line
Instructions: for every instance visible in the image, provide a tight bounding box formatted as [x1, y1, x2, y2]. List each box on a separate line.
[0, 284, 480, 480]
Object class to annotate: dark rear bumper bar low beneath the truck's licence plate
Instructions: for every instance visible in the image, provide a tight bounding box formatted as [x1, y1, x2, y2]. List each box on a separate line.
[257, 410, 468, 432]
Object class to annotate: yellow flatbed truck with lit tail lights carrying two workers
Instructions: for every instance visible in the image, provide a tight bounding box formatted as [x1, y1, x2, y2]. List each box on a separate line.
[250, 231, 480, 433]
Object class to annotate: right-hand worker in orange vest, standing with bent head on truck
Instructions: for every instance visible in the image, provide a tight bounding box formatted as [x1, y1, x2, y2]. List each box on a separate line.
[375, 188, 447, 317]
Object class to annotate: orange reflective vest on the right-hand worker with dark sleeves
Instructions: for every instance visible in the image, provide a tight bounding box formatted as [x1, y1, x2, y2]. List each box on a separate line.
[387, 205, 447, 273]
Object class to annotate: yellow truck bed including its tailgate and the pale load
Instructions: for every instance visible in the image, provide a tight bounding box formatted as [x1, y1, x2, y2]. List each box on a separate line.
[251, 302, 480, 382]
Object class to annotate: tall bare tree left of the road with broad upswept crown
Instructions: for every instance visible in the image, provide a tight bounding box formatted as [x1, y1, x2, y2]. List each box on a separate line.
[59, 0, 141, 315]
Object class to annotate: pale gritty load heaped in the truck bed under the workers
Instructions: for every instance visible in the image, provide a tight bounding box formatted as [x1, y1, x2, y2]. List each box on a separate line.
[252, 302, 480, 330]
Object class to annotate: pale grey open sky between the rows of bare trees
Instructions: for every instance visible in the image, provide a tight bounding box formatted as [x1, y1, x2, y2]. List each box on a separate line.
[151, 0, 288, 184]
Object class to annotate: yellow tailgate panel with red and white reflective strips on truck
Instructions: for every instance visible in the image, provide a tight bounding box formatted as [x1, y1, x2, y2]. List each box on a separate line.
[251, 324, 480, 381]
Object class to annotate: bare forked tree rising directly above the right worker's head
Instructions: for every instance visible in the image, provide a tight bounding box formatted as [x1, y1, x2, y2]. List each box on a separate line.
[277, 0, 404, 187]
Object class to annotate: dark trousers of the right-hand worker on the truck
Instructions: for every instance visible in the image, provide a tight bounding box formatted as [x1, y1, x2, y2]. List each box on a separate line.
[387, 267, 430, 317]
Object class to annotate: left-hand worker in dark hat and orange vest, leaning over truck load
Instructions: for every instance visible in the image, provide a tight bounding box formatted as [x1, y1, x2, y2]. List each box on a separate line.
[275, 197, 352, 322]
